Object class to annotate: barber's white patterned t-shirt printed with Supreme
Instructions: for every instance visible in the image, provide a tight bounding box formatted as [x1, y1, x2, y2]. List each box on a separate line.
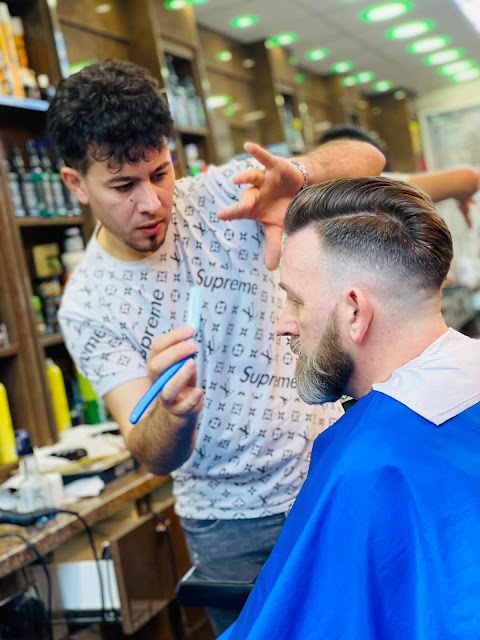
[59, 161, 343, 519]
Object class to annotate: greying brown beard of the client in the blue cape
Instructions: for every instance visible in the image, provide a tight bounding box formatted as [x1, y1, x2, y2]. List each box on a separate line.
[290, 310, 354, 404]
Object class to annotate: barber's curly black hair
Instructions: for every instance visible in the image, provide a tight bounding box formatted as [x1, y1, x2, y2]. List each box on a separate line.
[47, 60, 173, 173]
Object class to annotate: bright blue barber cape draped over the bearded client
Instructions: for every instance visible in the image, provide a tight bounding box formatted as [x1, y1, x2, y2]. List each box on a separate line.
[221, 390, 480, 640]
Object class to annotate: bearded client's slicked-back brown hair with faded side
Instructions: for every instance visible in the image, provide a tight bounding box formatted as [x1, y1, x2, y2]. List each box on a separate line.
[284, 177, 453, 291]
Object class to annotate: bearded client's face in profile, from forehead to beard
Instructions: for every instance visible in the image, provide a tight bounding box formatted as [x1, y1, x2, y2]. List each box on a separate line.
[277, 229, 353, 404]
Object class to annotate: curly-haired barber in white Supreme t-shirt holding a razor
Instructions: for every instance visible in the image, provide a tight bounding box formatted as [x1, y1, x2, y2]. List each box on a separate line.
[48, 60, 384, 632]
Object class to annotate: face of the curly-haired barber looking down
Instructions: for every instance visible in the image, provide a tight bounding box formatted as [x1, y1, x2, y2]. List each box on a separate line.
[62, 142, 175, 260]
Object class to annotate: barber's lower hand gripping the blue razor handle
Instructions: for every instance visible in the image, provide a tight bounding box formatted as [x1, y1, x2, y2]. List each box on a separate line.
[147, 327, 203, 423]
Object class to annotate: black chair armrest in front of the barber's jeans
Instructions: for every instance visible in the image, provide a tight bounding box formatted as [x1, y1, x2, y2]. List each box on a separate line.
[176, 567, 254, 609]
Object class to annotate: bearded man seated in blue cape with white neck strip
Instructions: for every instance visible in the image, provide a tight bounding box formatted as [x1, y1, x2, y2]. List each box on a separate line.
[216, 177, 480, 640]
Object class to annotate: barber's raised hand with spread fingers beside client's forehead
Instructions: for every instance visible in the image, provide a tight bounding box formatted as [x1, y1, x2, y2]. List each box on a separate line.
[218, 142, 304, 269]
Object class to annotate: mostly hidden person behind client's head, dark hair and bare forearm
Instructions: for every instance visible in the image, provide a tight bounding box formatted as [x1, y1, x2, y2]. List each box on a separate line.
[319, 124, 480, 227]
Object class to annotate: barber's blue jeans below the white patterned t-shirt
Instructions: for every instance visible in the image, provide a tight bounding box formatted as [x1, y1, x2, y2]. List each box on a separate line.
[180, 513, 286, 636]
